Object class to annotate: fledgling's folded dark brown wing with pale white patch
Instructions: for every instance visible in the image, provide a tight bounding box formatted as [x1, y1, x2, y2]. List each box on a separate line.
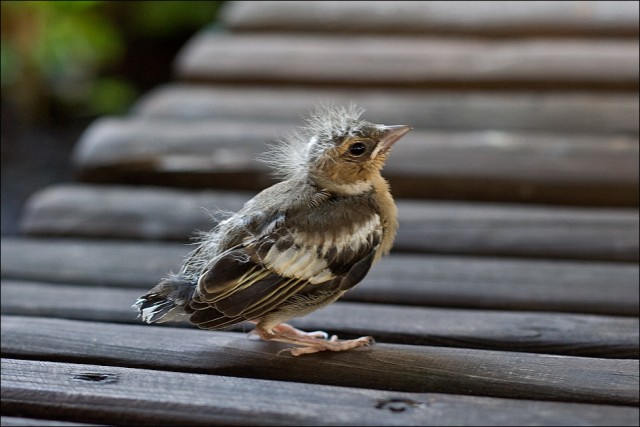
[190, 211, 382, 328]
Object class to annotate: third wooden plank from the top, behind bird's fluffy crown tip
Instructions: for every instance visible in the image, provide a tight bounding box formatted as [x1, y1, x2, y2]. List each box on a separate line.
[133, 83, 640, 136]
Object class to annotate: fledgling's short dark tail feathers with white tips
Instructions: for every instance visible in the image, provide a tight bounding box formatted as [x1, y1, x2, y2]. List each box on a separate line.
[132, 276, 196, 323]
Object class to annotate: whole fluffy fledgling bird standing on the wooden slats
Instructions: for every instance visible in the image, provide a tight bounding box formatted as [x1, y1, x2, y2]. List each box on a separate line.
[133, 104, 412, 356]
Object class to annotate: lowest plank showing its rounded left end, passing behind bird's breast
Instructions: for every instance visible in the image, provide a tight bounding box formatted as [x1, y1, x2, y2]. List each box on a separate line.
[16, 185, 640, 261]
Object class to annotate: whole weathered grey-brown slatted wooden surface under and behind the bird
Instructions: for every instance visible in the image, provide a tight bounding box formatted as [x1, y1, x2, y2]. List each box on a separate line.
[1, 1, 640, 426]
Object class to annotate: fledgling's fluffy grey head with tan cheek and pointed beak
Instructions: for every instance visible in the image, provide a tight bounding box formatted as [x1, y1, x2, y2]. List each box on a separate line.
[266, 106, 412, 195]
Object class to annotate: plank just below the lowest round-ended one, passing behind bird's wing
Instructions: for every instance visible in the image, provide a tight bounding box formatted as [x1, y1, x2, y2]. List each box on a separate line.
[0, 238, 639, 316]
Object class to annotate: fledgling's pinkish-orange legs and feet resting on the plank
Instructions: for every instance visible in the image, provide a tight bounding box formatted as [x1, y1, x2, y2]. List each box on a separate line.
[255, 323, 374, 356]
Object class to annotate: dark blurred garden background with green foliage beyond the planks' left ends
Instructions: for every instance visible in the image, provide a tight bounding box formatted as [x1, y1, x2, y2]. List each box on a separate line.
[1, 1, 223, 235]
